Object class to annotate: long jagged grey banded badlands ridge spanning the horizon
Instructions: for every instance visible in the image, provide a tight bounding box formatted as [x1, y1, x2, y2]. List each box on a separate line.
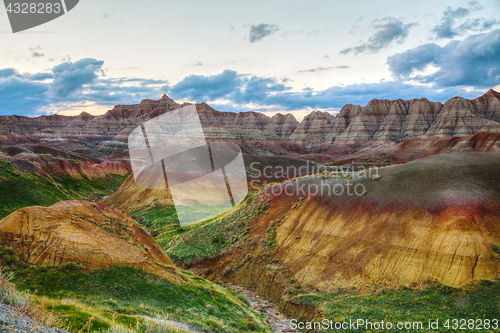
[0, 90, 500, 155]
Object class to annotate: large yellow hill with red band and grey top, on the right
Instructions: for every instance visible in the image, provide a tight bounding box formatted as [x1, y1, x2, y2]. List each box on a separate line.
[204, 153, 500, 293]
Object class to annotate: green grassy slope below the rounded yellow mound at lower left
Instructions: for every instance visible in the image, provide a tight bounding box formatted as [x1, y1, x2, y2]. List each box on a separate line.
[13, 264, 271, 332]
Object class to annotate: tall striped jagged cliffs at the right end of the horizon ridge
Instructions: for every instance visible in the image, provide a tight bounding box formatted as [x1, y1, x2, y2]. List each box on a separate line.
[320, 89, 500, 150]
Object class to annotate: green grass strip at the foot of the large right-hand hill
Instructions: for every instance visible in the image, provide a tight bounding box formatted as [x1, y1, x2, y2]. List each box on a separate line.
[297, 280, 500, 332]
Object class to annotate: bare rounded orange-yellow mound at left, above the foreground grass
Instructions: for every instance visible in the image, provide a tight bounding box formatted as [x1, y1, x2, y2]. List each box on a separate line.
[0, 200, 180, 281]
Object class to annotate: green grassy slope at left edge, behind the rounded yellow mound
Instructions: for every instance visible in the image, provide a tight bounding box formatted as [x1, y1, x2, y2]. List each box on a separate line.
[0, 161, 127, 219]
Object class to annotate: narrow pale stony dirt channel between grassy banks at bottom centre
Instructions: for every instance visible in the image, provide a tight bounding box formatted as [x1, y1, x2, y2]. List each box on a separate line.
[228, 285, 300, 333]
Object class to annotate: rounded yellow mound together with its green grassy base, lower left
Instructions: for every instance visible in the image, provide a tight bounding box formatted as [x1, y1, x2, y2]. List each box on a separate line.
[0, 201, 271, 332]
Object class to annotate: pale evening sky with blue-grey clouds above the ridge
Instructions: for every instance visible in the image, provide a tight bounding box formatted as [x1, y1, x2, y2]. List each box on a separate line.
[0, 0, 500, 117]
